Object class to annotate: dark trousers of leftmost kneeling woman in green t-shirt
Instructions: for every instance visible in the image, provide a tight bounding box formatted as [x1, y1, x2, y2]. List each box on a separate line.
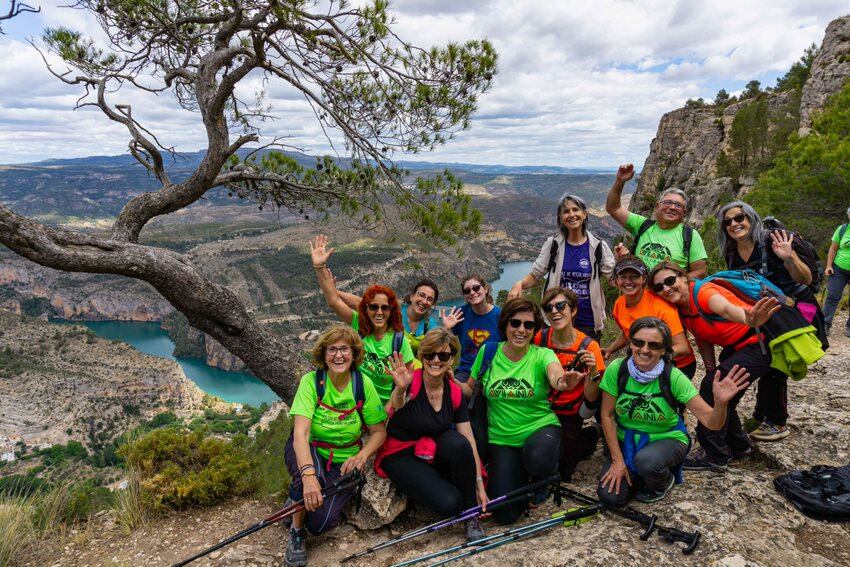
[283, 437, 354, 535]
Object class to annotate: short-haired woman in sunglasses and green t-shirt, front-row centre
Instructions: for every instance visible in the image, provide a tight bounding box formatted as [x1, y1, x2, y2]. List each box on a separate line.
[469, 297, 584, 524]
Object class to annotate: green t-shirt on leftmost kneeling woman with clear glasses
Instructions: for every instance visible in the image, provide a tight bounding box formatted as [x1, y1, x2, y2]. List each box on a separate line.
[289, 372, 387, 463]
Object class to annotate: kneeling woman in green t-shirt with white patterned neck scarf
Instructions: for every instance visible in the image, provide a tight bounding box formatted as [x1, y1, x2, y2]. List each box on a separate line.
[597, 317, 750, 506]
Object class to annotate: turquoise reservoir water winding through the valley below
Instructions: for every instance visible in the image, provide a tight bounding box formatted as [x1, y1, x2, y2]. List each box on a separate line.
[56, 262, 531, 406]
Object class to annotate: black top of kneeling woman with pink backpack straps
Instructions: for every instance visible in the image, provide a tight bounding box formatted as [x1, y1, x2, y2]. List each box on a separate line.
[387, 384, 469, 441]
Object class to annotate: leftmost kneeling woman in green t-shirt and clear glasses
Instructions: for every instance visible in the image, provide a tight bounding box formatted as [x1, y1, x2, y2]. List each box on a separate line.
[284, 325, 387, 566]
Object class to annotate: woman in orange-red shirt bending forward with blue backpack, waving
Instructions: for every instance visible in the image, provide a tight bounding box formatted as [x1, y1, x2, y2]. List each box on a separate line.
[649, 260, 780, 472]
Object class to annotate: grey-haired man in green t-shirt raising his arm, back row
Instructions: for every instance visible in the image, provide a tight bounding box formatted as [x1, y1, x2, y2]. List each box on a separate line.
[605, 164, 708, 279]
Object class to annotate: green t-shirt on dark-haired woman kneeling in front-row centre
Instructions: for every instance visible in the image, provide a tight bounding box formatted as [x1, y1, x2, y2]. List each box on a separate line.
[470, 343, 561, 447]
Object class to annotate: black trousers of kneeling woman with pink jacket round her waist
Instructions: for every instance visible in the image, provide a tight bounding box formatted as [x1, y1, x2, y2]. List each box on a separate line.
[381, 429, 478, 518]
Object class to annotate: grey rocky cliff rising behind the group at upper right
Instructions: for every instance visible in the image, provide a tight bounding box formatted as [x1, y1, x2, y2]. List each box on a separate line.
[630, 16, 850, 226]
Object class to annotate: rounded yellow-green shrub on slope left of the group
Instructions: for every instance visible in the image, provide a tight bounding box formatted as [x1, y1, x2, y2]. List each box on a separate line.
[119, 428, 257, 510]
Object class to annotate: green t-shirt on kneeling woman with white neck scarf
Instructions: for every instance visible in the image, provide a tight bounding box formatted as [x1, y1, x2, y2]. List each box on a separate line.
[599, 358, 699, 445]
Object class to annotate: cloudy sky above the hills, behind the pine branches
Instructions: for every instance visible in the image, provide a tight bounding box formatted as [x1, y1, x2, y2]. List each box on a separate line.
[0, 0, 850, 167]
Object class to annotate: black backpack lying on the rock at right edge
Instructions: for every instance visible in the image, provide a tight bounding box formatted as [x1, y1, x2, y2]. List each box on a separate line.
[773, 464, 850, 522]
